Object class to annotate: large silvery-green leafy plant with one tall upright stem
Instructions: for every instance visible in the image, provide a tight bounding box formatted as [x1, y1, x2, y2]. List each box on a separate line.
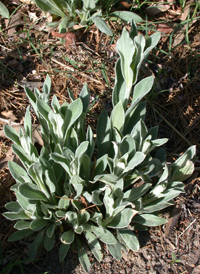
[4, 23, 195, 271]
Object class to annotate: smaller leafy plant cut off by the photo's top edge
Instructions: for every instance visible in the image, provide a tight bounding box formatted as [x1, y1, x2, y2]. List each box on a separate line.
[33, 0, 143, 36]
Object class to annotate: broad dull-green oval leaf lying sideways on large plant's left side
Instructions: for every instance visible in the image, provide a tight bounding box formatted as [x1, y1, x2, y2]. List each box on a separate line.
[19, 183, 47, 201]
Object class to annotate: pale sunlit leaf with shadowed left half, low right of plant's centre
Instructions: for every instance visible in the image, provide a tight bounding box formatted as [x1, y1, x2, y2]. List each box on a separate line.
[105, 208, 135, 228]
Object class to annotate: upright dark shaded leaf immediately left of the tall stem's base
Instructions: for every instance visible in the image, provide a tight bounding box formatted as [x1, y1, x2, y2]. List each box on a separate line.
[97, 110, 111, 157]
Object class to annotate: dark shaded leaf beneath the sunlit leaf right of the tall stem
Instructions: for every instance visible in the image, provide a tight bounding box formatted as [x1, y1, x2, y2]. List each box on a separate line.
[123, 101, 146, 135]
